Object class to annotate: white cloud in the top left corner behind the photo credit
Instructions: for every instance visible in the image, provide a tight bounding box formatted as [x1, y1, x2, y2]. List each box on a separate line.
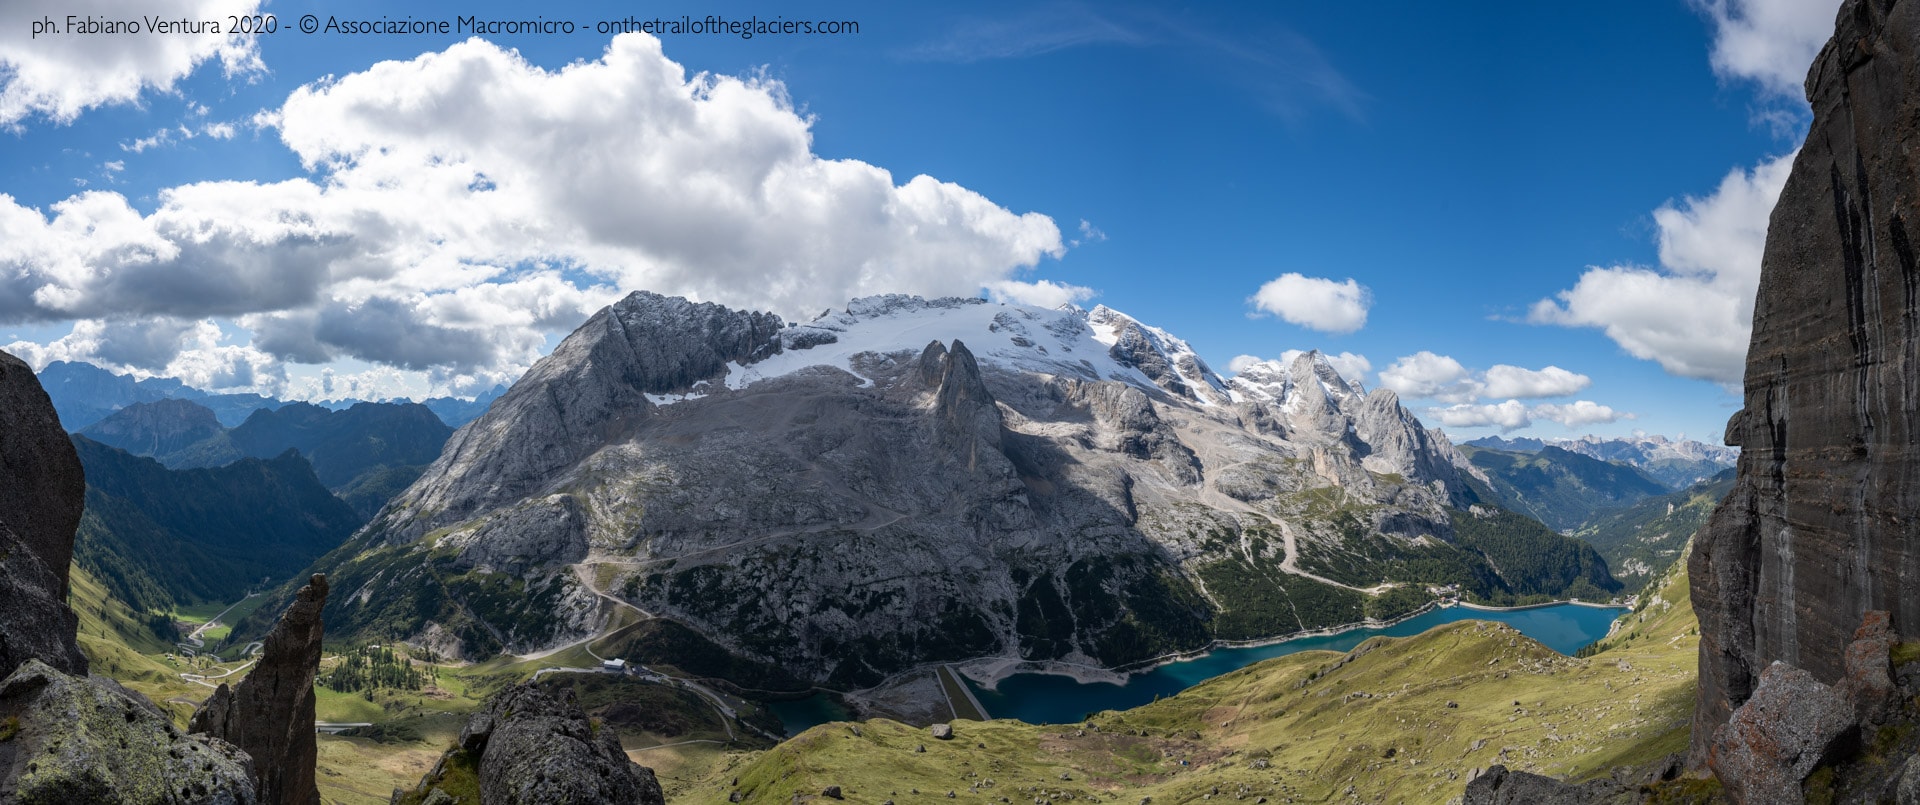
[0, 0, 265, 127]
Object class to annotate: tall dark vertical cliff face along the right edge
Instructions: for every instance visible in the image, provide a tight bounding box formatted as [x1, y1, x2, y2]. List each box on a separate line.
[1690, 0, 1920, 765]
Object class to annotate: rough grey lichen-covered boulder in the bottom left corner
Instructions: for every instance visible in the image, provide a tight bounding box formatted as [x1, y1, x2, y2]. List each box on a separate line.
[0, 659, 257, 805]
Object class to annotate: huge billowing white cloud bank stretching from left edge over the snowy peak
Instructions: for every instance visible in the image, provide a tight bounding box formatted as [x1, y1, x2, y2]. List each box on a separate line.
[0, 35, 1096, 394]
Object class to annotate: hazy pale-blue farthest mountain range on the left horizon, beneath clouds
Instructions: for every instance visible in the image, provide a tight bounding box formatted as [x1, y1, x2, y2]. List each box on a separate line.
[36, 361, 507, 432]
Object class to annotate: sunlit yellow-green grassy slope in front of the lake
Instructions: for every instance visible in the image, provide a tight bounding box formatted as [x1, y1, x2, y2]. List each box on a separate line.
[691, 567, 1697, 805]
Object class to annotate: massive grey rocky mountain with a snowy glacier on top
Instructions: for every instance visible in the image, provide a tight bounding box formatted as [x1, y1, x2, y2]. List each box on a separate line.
[236, 292, 1622, 690]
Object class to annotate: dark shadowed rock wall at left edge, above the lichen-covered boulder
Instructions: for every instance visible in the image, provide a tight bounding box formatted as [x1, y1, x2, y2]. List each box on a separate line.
[0, 352, 86, 676]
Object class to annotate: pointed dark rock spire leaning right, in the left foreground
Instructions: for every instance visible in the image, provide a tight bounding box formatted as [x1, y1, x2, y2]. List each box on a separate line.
[190, 574, 326, 805]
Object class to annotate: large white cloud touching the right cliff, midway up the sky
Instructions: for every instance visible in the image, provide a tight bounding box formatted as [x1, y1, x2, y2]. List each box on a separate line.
[1528, 154, 1795, 386]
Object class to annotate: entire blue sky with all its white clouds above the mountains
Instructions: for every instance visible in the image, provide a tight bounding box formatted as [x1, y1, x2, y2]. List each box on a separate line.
[0, 0, 1836, 442]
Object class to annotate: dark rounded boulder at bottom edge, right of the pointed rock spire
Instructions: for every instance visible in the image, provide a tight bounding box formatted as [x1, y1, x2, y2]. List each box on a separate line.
[394, 684, 666, 805]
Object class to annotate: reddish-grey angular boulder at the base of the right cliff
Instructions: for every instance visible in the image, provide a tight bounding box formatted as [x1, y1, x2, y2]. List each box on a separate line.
[1707, 663, 1855, 803]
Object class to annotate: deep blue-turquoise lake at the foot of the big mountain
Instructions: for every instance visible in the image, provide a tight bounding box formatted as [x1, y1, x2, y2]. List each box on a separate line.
[770, 603, 1624, 736]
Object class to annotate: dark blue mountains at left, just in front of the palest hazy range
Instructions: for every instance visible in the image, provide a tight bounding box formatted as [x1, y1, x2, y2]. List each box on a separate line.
[81, 400, 453, 521]
